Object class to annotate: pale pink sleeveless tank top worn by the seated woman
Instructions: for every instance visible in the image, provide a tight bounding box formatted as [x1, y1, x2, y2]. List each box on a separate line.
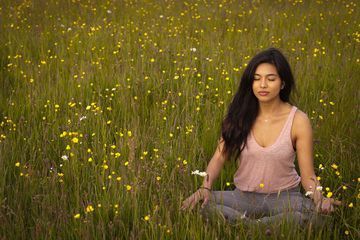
[234, 106, 301, 193]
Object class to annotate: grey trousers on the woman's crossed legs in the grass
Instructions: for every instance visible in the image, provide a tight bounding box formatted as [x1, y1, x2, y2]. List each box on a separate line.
[201, 187, 319, 224]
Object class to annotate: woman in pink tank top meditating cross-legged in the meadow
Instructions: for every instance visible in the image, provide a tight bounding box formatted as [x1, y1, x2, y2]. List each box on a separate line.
[181, 48, 340, 226]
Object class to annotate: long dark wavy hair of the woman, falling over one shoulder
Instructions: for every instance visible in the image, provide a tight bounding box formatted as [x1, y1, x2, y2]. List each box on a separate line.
[221, 48, 295, 159]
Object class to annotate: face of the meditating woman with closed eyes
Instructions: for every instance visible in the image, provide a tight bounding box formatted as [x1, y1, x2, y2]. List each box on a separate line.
[252, 63, 282, 102]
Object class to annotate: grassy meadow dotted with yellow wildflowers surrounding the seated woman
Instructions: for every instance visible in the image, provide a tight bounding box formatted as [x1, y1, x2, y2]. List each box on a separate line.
[0, 0, 360, 239]
